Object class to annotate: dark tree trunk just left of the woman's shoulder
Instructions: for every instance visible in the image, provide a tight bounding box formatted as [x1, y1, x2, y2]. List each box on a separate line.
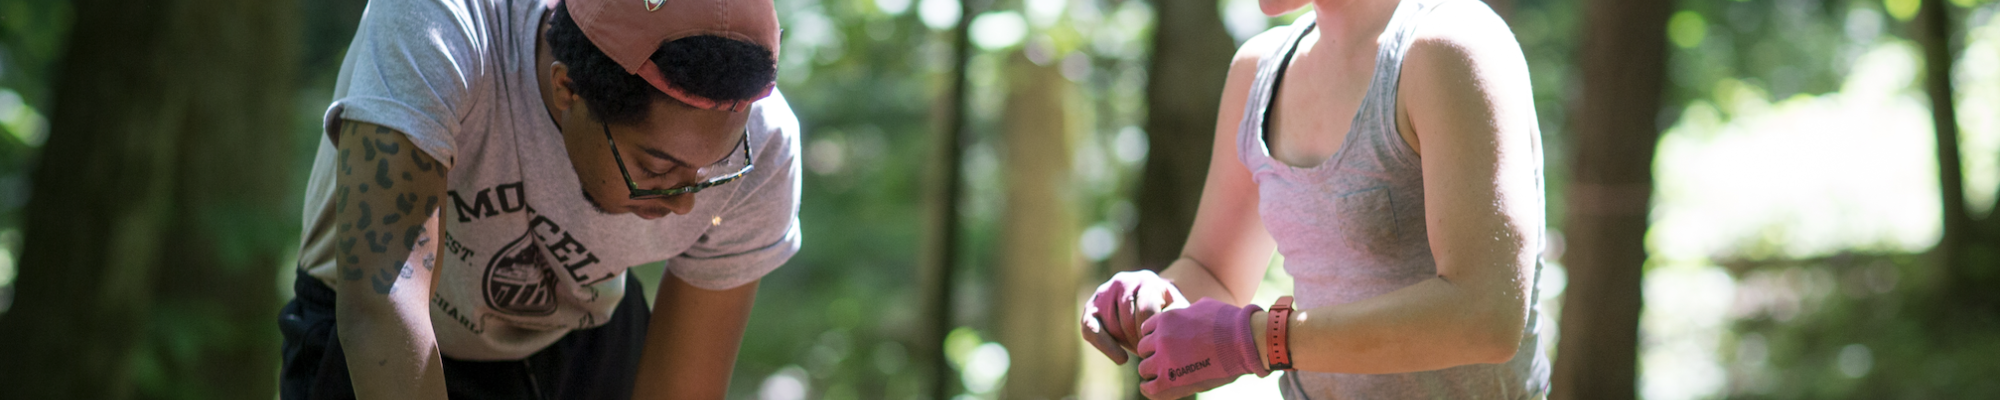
[1134, 0, 1236, 270]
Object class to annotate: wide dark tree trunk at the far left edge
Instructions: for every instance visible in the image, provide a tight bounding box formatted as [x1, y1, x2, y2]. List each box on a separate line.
[0, 0, 306, 400]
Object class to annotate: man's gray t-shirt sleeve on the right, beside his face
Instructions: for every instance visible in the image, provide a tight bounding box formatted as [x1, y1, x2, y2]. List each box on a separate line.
[666, 92, 800, 290]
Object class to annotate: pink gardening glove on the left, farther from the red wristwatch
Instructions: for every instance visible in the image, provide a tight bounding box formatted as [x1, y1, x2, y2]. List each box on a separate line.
[1084, 270, 1188, 364]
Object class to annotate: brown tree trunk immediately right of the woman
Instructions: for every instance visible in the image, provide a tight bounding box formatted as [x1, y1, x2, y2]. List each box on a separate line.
[1552, 0, 1674, 400]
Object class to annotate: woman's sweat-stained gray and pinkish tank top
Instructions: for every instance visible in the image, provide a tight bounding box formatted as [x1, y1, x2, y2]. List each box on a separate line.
[1236, 0, 1548, 398]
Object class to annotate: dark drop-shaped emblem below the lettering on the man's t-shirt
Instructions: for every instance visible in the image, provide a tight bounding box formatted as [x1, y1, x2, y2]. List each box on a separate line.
[482, 232, 556, 316]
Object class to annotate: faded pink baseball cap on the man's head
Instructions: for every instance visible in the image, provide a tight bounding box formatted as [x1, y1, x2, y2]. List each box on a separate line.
[564, 0, 778, 112]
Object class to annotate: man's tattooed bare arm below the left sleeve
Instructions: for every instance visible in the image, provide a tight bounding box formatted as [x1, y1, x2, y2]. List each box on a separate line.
[334, 120, 446, 400]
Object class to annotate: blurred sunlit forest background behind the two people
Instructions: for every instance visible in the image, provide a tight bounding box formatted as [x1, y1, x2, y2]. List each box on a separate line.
[0, 0, 2000, 400]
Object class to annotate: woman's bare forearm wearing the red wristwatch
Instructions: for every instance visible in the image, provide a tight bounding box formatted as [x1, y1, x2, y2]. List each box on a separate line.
[1252, 278, 1526, 374]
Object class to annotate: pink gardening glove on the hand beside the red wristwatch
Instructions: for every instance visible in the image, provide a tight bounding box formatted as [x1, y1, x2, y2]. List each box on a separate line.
[1138, 298, 1270, 398]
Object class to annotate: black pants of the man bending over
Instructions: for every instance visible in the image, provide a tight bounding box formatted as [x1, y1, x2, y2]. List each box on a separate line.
[278, 272, 652, 400]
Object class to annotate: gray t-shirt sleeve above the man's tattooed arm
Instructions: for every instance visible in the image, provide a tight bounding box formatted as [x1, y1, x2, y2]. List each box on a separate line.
[324, 0, 486, 166]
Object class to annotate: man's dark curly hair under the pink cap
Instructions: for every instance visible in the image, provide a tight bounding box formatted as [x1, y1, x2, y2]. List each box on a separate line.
[548, 6, 778, 124]
